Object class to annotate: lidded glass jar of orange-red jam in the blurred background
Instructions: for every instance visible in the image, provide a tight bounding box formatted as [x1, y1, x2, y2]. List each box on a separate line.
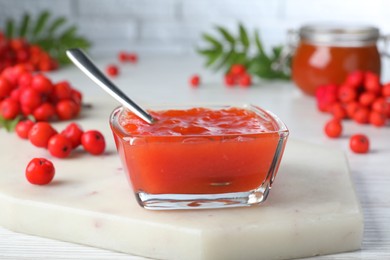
[292, 25, 381, 95]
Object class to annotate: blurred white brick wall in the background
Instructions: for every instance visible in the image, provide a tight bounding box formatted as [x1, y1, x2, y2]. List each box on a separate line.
[0, 0, 390, 54]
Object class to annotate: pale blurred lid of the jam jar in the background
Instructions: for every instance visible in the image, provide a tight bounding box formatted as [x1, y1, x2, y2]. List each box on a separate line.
[299, 24, 380, 46]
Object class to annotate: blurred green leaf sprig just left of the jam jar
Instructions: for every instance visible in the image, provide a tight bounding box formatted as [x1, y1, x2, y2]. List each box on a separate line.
[197, 23, 290, 79]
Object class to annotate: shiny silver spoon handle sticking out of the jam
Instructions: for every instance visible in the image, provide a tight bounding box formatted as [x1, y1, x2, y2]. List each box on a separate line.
[66, 49, 155, 124]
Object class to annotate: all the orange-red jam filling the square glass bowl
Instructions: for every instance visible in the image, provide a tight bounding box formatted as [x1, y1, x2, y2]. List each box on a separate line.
[112, 108, 279, 194]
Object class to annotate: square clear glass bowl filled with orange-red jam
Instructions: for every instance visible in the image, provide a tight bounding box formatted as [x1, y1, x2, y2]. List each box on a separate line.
[110, 104, 289, 210]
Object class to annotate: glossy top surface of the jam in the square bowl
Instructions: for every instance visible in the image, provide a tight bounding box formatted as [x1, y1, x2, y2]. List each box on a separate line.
[119, 107, 275, 136]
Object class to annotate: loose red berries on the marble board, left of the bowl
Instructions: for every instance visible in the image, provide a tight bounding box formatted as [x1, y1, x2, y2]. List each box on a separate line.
[19, 122, 106, 185]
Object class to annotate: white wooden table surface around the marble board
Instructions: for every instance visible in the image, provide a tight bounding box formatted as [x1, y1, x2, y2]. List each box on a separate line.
[0, 56, 390, 260]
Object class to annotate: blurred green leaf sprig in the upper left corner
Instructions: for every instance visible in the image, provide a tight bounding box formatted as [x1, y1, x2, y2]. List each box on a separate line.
[5, 11, 91, 64]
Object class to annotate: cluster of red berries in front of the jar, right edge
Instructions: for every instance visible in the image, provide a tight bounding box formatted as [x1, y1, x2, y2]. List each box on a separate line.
[316, 71, 390, 153]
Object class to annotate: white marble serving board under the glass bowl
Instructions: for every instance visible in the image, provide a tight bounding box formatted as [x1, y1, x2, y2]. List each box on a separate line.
[0, 99, 363, 260]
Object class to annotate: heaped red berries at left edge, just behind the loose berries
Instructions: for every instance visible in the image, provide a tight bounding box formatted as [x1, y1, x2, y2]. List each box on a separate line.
[0, 64, 82, 121]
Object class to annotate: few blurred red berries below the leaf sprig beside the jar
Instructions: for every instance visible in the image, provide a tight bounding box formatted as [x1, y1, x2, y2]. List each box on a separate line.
[189, 64, 252, 88]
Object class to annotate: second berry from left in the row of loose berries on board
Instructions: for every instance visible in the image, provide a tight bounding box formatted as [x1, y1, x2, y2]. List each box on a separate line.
[28, 122, 57, 148]
